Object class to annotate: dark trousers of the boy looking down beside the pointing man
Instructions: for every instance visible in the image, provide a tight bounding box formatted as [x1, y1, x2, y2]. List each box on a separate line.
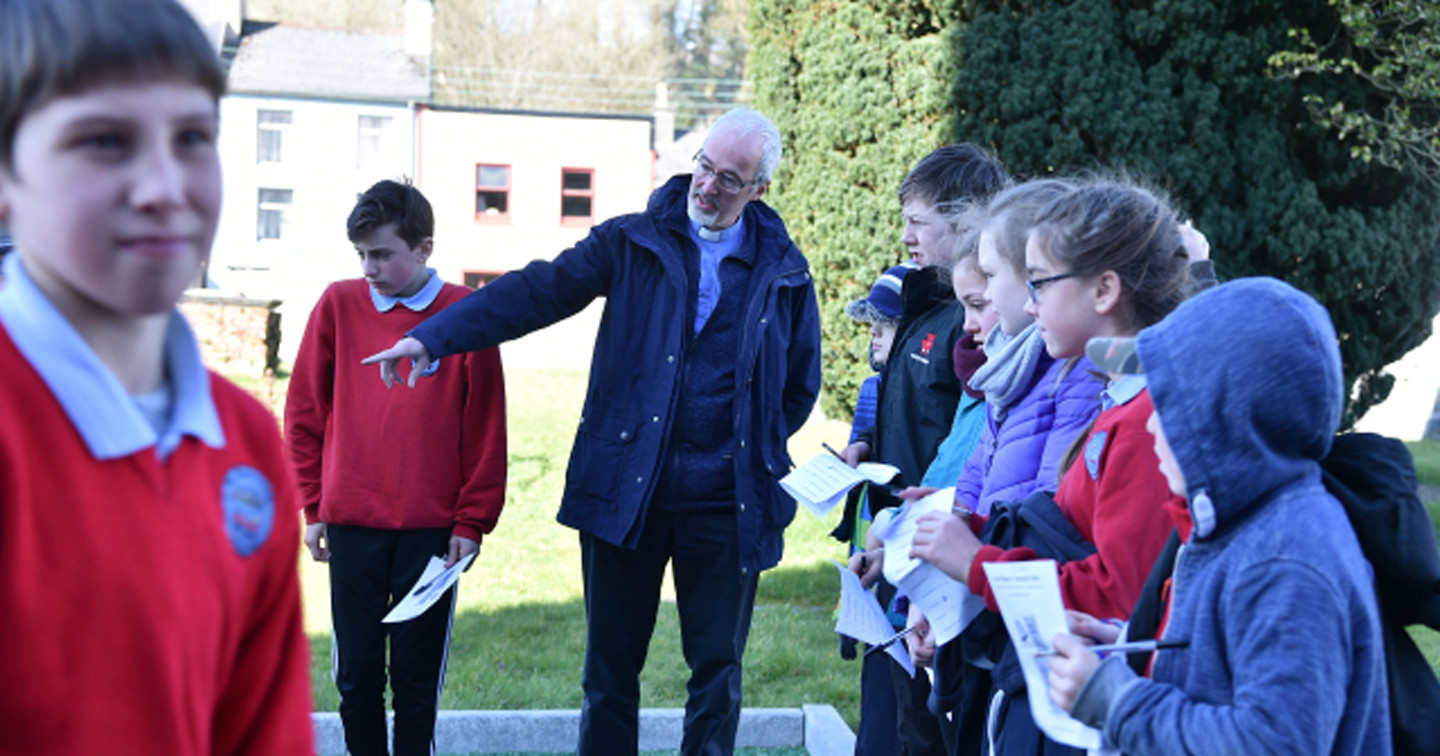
[327, 526, 455, 756]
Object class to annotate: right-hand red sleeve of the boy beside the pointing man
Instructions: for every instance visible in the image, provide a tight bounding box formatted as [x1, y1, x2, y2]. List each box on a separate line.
[451, 347, 505, 541]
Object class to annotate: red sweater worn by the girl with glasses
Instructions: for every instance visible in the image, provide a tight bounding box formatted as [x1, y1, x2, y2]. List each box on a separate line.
[968, 393, 1174, 618]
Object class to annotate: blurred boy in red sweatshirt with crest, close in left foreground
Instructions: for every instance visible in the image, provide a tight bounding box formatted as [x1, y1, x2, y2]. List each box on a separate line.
[0, 0, 314, 756]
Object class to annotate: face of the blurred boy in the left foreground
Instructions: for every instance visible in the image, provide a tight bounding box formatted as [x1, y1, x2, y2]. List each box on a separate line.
[0, 81, 220, 321]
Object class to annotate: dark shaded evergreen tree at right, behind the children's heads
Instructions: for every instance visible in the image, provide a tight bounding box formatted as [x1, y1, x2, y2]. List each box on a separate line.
[955, 0, 1440, 422]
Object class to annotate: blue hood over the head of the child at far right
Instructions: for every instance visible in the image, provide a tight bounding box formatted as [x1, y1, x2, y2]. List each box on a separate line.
[1136, 278, 1345, 539]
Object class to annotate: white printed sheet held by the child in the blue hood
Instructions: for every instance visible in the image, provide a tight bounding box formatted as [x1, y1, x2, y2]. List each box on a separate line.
[984, 559, 1100, 749]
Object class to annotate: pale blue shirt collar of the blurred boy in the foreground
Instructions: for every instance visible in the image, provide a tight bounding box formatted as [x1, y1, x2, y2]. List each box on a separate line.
[0, 255, 225, 461]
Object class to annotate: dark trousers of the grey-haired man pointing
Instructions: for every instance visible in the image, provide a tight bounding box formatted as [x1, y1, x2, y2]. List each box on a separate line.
[577, 510, 757, 756]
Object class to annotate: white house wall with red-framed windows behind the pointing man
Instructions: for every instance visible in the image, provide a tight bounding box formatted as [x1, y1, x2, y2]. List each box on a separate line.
[416, 108, 654, 369]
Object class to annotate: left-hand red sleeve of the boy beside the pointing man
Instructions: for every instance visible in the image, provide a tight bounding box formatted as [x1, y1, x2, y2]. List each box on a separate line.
[285, 287, 336, 524]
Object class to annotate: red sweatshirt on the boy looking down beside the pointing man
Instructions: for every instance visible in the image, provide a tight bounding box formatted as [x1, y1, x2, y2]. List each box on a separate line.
[285, 278, 505, 541]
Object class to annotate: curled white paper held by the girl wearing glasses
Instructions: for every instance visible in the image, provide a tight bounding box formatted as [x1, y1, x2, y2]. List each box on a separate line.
[873, 488, 985, 645]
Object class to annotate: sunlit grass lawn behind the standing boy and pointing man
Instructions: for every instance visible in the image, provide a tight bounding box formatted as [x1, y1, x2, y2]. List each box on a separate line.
[289, 370, 860, 731]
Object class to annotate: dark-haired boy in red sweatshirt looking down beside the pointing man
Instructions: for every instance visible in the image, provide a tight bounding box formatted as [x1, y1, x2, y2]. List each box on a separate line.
[285, 181, 505, 756]
